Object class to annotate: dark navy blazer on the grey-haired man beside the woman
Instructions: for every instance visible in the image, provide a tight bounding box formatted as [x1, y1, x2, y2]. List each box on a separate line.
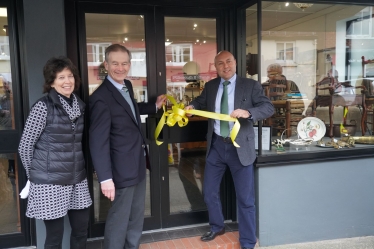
[89, 78, 156, 188]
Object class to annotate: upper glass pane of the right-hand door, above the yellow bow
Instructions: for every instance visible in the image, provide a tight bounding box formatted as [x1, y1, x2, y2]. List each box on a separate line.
[165, 17, 217, 104]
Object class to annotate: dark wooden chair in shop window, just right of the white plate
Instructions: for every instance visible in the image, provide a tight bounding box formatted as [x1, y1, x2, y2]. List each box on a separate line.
[313, 77, 366, 138]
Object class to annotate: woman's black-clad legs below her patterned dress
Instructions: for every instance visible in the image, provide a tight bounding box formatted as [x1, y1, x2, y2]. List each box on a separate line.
[44, 208, 89, 249]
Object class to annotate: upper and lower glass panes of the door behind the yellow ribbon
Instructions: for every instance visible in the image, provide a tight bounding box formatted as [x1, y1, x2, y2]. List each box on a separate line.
[156, 15, 217, 227]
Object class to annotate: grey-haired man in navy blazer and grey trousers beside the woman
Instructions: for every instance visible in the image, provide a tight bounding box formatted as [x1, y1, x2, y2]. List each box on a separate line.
[89, 44, 166, 249]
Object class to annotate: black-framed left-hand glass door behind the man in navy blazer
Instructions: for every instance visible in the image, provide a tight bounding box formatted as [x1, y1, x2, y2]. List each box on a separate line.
[79, 3, 161, 237]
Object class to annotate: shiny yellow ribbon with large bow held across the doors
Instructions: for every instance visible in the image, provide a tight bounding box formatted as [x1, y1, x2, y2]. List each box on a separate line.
[155, 95, 240, 147]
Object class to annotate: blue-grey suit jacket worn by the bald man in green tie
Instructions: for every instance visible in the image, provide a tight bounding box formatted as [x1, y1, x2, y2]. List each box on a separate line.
[191, 76, 274, 166]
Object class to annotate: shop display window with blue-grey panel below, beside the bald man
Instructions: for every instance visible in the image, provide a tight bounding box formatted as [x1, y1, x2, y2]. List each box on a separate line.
[238, 1, 374, 246]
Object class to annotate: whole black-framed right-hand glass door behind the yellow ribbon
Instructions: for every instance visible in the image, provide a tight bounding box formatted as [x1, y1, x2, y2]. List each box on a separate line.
[155, 7, 234, 228]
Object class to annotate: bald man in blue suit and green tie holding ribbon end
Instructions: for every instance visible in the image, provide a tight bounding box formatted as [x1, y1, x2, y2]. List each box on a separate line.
[185, 51, 274, 249]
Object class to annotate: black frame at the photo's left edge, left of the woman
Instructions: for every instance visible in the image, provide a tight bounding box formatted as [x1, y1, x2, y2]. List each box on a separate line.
[0, 0, 35, 248]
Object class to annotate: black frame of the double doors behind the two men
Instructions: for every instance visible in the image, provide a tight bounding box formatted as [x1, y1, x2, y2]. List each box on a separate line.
[65, 1, 233, 237]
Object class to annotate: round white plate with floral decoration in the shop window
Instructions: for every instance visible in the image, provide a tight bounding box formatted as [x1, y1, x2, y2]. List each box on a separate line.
[297, 117, 326, 141]
